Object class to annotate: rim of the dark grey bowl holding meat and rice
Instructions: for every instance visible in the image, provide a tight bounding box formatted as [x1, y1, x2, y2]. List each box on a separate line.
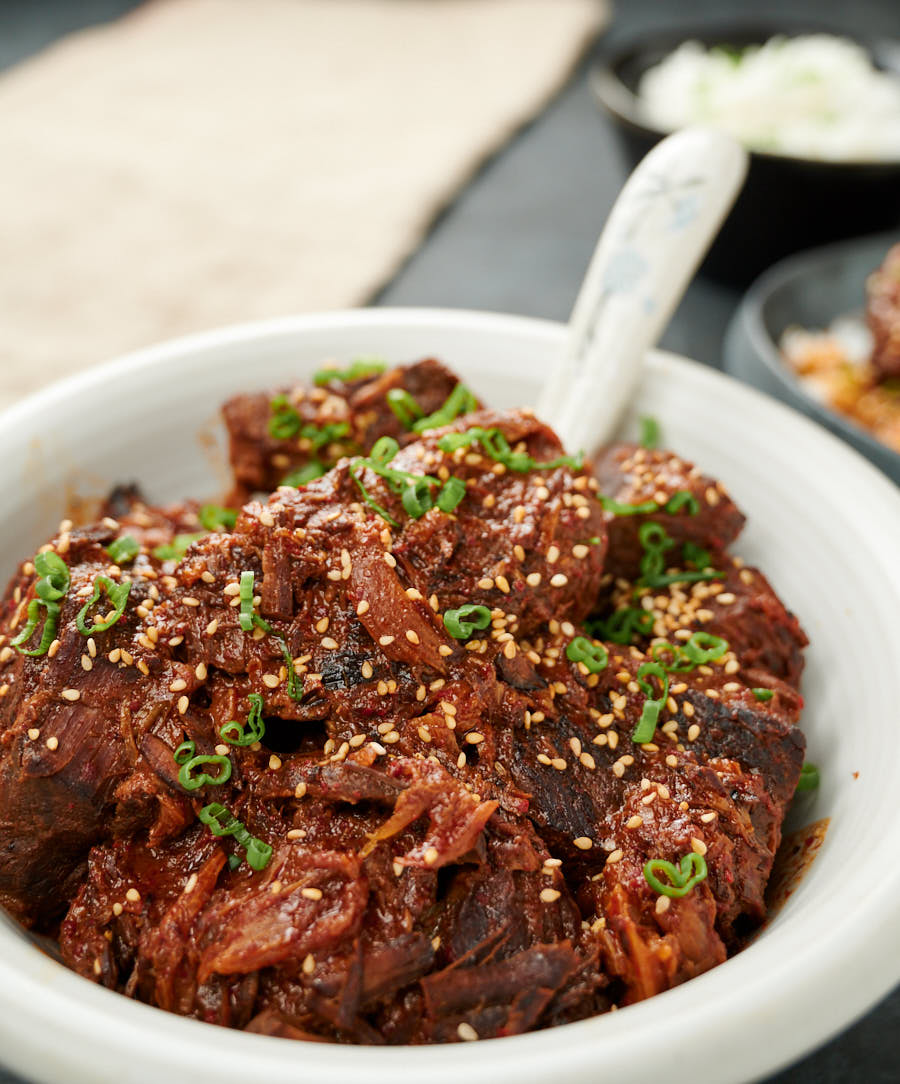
[727, 227, 900, 470]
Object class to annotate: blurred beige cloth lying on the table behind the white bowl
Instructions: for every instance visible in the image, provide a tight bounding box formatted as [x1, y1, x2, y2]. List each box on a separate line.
[0, 0, 605, 407]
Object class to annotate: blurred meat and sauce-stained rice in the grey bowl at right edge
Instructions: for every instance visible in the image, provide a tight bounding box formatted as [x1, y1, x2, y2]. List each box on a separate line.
[781, 245, 900, 452]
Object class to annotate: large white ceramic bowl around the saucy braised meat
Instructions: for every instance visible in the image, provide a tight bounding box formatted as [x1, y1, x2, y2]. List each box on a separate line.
[0, 309, 900, 1084]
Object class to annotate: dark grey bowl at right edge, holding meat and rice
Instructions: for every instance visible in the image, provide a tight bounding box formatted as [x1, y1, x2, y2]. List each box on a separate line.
[724, 232, 900, 483]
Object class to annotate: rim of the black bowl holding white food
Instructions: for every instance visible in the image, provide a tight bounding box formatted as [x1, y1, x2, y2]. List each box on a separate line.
[590, 16, 900, 168]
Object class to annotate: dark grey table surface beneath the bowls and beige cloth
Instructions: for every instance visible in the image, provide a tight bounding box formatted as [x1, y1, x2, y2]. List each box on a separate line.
[0, 0, 900, 1084]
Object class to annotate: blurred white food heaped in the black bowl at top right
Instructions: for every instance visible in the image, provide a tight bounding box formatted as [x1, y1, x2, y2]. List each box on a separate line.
[638, 34, 900, 162]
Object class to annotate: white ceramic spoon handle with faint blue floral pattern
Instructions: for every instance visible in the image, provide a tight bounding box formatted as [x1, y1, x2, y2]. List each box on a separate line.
[537, 128, 747, 452]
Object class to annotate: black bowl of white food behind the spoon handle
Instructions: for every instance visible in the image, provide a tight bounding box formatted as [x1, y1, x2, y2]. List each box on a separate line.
[592, 22, 900, 286]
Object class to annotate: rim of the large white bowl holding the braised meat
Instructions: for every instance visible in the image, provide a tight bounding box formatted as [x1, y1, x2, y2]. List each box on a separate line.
[0, 308, 900, 1084]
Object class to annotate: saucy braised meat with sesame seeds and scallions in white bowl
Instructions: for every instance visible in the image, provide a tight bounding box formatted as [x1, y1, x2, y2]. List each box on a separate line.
[0, 360, 814, 1044]
